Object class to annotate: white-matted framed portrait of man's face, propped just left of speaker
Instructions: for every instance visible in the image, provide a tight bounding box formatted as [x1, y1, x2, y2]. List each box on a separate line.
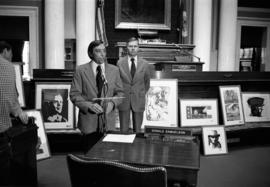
[36, 82, 74, 129]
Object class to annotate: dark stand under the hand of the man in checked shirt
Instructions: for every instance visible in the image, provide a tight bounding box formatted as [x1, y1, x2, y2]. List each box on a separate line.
[8, 118, 37, 186]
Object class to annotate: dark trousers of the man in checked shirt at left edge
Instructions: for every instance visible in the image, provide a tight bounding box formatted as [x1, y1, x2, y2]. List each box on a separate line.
[0, 132, 11, 186]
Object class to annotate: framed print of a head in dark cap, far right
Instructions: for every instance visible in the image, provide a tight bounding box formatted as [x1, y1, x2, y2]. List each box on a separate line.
[242, 92, 270, 122]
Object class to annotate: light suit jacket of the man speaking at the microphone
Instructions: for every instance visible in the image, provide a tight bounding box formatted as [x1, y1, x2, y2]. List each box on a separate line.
[70, 61, 124, 134]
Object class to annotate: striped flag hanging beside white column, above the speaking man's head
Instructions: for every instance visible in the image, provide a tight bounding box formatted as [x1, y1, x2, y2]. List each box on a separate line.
[96, 0, 108, 47]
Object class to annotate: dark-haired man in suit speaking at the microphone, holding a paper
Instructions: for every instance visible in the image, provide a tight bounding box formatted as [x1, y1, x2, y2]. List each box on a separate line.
[70, 40, 123, 152]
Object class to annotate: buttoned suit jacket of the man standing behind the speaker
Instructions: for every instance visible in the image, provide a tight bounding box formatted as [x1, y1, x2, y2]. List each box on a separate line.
[117, 56, 151, 112]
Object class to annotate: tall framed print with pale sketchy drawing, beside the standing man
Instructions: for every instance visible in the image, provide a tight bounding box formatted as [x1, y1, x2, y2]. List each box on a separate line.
[142, 79, 178, 128]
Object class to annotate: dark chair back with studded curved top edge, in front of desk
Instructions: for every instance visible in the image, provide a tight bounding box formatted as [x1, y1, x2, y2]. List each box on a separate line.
[67, 154, 167, 187]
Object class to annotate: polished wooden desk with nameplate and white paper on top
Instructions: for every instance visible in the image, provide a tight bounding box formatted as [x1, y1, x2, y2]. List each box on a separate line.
[86, 137, 200, 187]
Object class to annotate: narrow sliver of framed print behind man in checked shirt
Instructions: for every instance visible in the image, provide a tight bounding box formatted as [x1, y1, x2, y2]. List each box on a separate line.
[13, 62, 25, 107]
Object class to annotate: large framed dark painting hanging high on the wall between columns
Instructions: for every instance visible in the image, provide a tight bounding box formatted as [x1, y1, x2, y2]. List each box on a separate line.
[115, 0, 171, 30]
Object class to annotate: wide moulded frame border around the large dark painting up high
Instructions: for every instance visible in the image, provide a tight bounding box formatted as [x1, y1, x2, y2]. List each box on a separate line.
[115, 0, 171, 30]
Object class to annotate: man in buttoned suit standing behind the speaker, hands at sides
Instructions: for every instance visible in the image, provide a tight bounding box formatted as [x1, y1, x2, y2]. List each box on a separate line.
[117, 38, 150, 133]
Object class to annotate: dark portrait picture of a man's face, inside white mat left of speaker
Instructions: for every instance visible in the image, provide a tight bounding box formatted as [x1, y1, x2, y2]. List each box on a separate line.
[42, 89, 68, 122]
